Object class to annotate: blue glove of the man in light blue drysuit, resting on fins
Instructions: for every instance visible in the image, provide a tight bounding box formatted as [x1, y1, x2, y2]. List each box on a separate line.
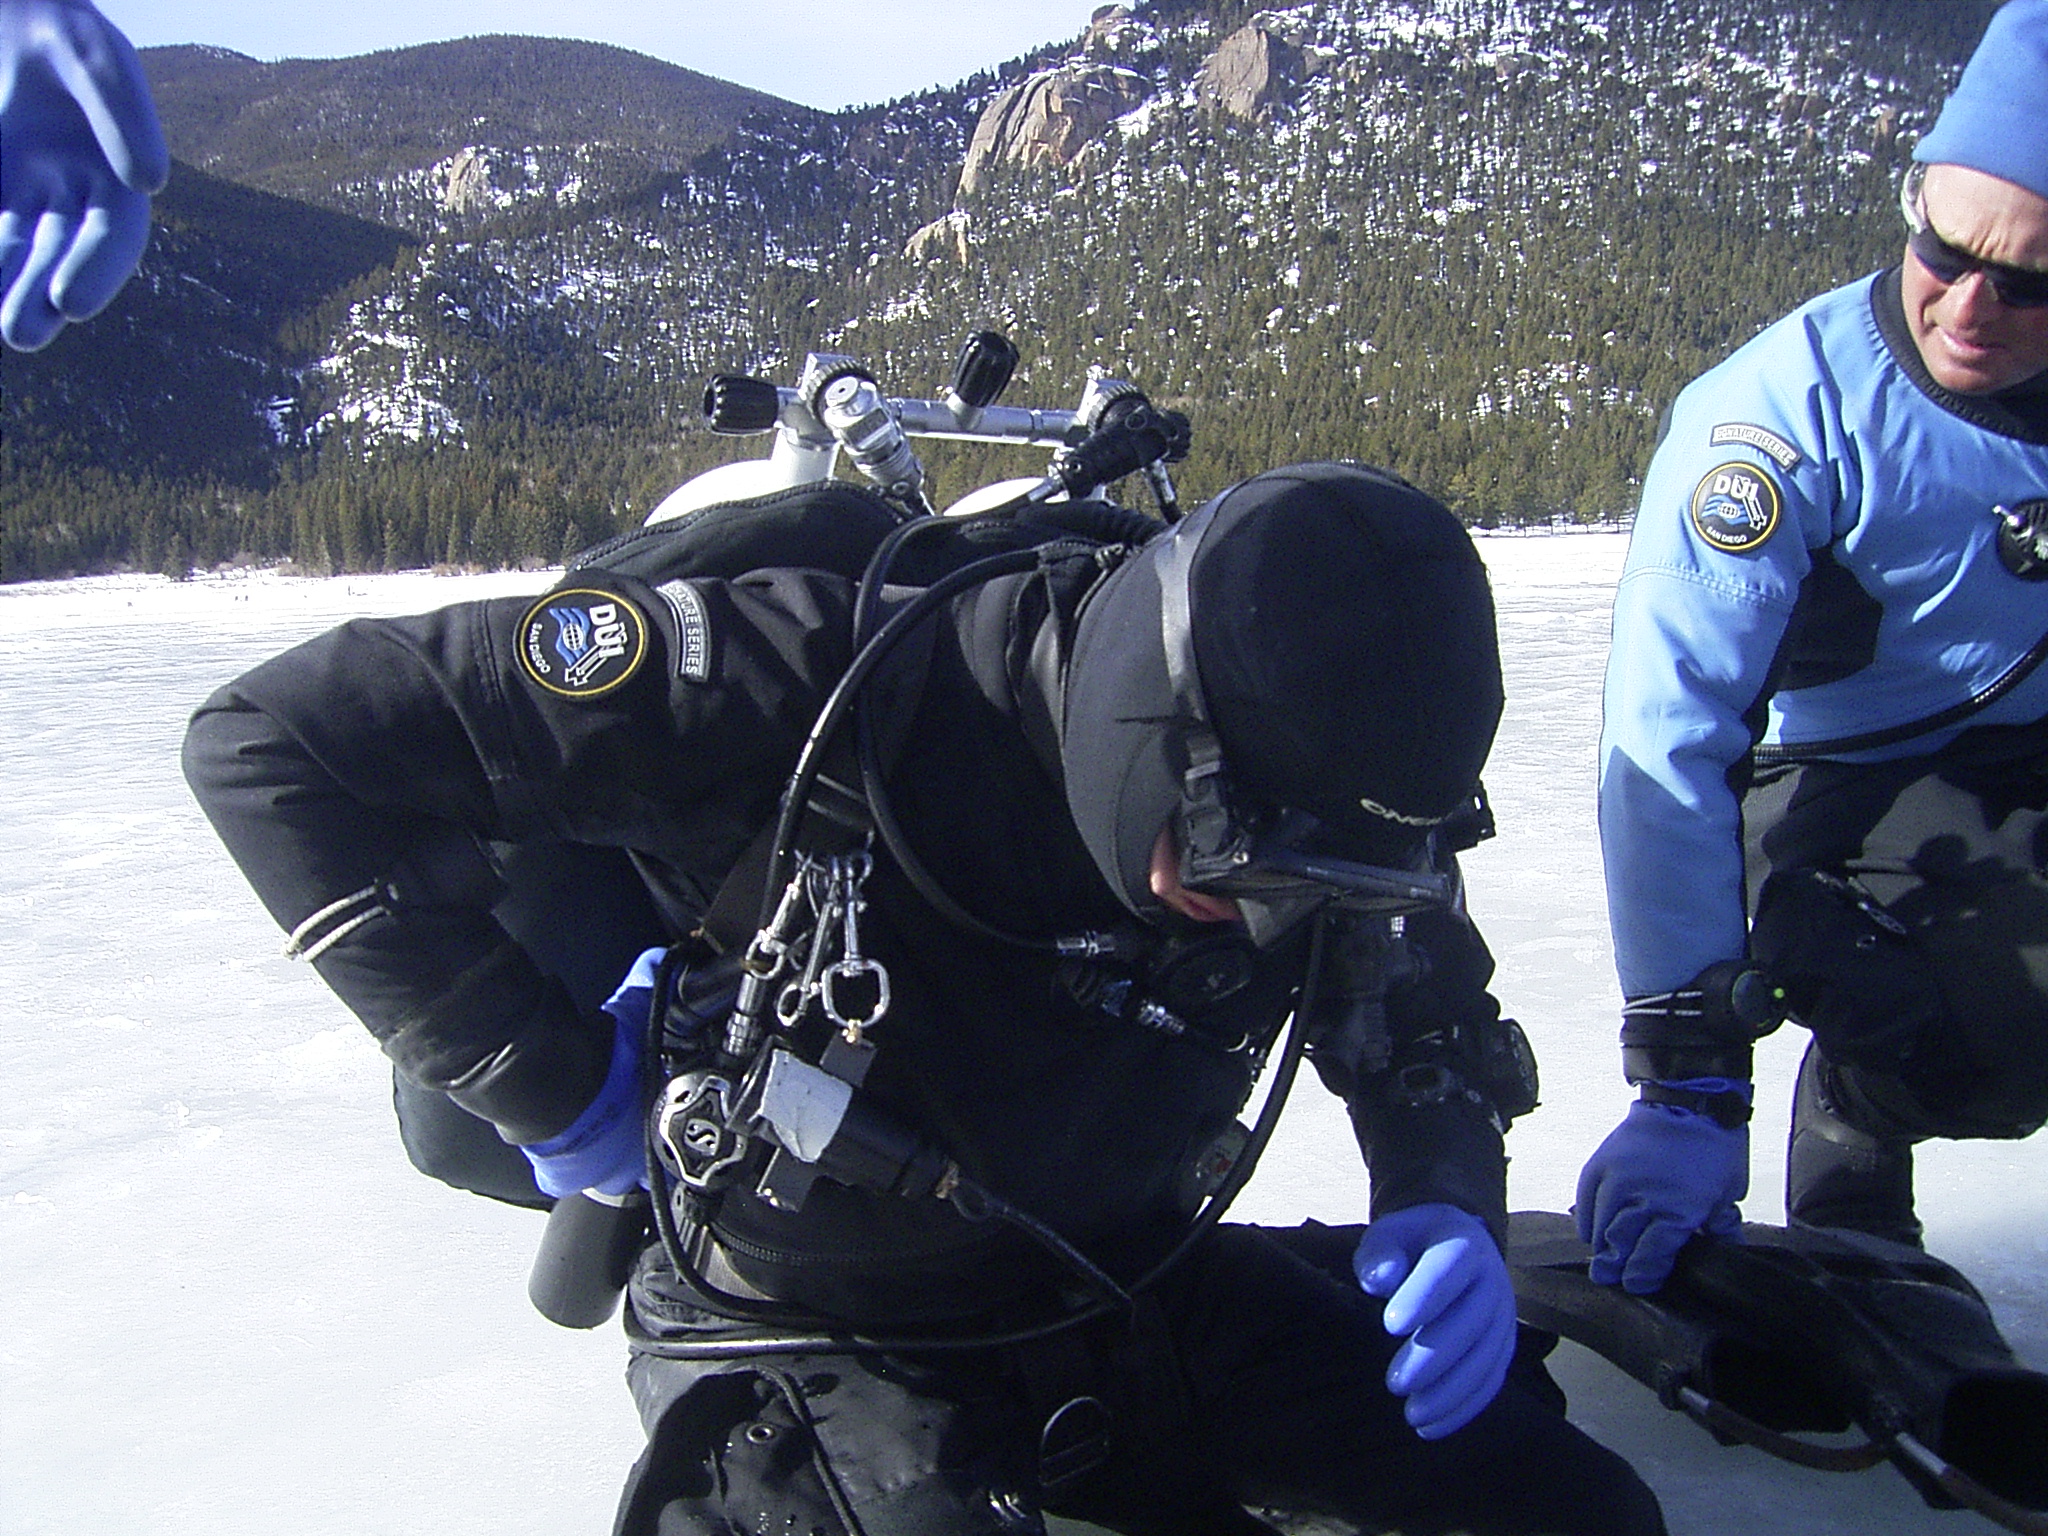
[1573, 1077, 1751, 1296]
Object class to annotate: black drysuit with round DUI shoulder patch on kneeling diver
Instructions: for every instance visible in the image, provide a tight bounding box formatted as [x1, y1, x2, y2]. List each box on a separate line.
[186, 520, 1661, 1532]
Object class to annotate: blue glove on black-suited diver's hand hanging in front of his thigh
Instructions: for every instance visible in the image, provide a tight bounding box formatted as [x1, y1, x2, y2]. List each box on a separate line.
[1352, 1204, 1516, 1440]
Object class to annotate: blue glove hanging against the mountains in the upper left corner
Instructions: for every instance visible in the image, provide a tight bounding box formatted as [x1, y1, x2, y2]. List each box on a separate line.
[0, 0, 170, 352]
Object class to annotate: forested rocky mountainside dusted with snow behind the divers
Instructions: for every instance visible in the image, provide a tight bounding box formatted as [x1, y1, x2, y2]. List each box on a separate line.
[0, 0, 1995, 578]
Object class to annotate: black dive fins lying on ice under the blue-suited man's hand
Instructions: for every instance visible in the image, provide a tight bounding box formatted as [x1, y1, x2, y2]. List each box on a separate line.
[1507, 1210, 2048, 1536]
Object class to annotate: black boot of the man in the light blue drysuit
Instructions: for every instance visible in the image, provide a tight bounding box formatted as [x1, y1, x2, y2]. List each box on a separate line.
[1786, 1044, 1921, 1247]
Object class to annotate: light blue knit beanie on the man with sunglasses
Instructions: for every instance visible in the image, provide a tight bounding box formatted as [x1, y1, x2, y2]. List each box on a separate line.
[1913, 0, 2048, 197]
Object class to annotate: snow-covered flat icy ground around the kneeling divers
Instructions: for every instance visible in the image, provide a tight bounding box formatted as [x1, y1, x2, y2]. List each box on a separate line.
[0, 535, 2048, 1536]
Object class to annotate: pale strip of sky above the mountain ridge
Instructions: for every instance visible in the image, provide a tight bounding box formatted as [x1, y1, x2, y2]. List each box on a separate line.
[100, 0, 1104, 111]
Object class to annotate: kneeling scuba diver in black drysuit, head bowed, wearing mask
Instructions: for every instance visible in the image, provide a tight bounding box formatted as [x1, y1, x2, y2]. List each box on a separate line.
[186, 465, 1663, 1536]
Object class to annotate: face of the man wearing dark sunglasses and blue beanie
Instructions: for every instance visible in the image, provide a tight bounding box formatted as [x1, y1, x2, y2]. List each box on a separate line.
[1901, 166, 2048, 395]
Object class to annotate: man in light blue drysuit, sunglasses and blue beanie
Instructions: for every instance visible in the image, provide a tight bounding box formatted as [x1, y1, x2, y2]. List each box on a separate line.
[1577, 0, 2048, 1292]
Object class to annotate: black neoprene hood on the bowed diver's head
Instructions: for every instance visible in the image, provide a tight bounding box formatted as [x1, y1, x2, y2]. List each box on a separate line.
[1061, 463, 1501, 915]
